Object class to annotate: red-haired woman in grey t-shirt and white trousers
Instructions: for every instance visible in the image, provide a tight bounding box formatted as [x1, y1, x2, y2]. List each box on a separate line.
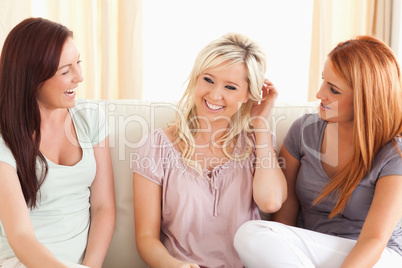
[235, 36, 402, 268]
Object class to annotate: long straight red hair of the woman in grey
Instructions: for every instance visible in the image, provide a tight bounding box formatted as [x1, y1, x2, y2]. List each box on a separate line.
[314, 36, 402, 218]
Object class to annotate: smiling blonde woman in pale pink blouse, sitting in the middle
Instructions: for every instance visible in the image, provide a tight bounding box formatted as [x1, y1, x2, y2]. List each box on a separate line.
[132, 33, 287, 268]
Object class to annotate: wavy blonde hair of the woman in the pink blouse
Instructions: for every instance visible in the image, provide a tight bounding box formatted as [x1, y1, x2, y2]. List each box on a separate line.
[174, 33, 266, 173]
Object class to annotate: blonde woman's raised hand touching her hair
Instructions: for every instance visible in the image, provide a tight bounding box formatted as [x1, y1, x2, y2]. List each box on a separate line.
[250, 79, 278, 129]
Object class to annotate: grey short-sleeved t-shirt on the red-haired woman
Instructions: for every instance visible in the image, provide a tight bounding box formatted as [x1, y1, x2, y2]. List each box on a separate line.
[284, 113, 402, 255]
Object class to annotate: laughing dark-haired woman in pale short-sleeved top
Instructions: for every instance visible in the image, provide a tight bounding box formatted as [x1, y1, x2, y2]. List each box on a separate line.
[0, 18, 115, 268]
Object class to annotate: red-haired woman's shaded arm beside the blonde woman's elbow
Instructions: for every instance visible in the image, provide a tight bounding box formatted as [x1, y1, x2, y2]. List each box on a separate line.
[273, 145, 300, 226]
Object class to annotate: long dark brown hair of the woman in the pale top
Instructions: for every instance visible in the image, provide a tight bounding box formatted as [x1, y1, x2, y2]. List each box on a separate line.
[0, 18, 72, 208]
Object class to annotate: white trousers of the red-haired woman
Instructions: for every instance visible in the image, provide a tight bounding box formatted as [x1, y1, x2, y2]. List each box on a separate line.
[234, 221, 402, 268]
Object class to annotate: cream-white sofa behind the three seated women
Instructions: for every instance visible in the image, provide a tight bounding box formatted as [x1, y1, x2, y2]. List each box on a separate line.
[96, 100, 317, 268]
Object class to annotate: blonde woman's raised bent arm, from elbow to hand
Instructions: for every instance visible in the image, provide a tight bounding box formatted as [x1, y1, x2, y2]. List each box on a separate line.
[251, 79, 287, 213]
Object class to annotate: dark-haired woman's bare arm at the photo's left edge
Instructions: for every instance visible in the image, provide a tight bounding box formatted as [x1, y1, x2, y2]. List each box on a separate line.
[0, 162, 67, 268]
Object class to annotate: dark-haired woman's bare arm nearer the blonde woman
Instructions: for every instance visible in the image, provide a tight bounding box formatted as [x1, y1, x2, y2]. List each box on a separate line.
[82, 137, 116, 268]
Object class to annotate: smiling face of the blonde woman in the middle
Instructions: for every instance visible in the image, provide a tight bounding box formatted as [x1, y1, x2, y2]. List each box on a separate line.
[194, 63, 249, 122]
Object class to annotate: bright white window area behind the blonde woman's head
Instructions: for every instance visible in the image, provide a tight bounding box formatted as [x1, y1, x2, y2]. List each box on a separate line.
[143, 0, 313, 102]
